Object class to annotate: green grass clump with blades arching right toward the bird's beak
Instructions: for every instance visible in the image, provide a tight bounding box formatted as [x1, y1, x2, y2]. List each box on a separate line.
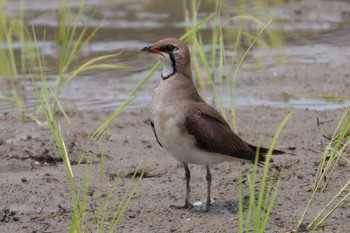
[56, 0, 126, 99]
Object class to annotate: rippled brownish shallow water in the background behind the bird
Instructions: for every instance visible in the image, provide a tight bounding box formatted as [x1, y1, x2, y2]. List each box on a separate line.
[0, 0, 350, 112]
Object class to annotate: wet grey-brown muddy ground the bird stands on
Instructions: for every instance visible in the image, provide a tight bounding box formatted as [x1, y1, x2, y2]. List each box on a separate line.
[0, 0, 350, 233]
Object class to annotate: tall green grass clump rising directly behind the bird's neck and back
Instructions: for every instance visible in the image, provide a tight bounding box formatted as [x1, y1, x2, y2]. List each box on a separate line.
[183, 0, 283, 130]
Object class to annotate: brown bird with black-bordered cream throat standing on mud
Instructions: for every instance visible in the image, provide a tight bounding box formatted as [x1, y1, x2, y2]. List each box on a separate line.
[141, 38, 284, 209]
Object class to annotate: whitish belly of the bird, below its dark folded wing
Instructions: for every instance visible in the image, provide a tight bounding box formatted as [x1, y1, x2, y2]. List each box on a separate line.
[152, 111, 233, 166]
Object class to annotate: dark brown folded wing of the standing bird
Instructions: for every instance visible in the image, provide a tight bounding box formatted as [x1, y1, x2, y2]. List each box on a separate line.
[184, 102, 265, 161]
